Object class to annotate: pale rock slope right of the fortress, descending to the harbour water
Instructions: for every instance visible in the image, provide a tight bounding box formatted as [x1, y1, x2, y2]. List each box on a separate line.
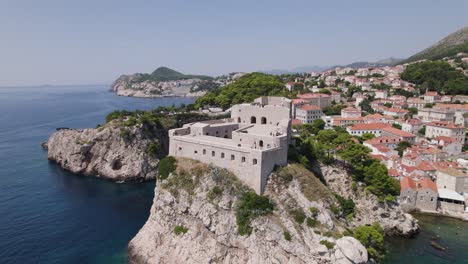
[320, 165, 419, 237]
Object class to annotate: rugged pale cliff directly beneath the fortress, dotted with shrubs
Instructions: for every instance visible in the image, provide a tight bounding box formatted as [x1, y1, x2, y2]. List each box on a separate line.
[128, 159, 417, 263]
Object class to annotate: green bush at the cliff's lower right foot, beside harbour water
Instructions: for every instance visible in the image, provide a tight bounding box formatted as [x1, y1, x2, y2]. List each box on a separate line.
[354, 223, 385, 262]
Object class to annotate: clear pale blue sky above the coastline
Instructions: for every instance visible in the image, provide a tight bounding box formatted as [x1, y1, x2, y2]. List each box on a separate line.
[0, 0, 468, 86]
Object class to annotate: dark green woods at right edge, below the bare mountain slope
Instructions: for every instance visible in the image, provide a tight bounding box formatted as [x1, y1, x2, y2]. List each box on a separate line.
[401, 61, 468, 95]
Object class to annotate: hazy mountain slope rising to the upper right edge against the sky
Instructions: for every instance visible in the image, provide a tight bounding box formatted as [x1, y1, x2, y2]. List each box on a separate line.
[399, 26, 468, 63]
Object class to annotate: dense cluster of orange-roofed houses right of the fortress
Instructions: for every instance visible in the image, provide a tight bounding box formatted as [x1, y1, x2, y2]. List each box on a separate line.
[289, 65, 468, 214]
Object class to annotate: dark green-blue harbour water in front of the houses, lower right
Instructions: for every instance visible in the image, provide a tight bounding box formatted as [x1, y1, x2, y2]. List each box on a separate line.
[384, 215, 468, 264]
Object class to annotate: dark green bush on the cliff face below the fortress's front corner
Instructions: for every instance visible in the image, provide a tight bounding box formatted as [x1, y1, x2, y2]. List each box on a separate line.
[236, 191, 274, 236]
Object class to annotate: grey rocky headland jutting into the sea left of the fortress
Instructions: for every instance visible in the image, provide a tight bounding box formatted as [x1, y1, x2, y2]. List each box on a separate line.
[43, 124, 164, 181]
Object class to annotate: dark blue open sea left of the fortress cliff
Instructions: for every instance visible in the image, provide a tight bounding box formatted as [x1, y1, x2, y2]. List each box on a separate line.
[0, 86, 193, 263]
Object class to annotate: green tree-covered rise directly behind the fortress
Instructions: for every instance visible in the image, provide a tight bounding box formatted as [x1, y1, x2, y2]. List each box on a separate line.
[195, 72, 293, 109]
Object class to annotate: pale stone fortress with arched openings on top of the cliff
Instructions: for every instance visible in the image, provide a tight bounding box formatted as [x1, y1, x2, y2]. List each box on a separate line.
[169, 97, 291, 194]
